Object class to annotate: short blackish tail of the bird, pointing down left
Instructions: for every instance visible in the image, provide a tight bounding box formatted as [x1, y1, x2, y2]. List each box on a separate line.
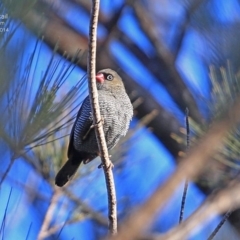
[55, 158, 81, 187]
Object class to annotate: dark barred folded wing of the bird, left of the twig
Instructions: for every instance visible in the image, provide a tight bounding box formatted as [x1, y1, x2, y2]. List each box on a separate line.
[68, 97, 93, 158]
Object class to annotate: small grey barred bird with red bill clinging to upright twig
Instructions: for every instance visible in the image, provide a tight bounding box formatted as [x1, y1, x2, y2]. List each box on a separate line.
[55, 69, 133, 187]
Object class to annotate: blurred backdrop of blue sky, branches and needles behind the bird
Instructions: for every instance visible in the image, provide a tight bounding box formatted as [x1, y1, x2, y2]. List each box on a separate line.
[0, 0, 240, 240]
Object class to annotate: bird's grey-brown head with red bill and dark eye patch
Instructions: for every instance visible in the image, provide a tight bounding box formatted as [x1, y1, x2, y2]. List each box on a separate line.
[96, 68, 124, 91]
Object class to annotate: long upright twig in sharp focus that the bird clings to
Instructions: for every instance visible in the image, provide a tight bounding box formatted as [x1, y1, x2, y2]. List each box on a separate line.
[88, 0, 117, 235]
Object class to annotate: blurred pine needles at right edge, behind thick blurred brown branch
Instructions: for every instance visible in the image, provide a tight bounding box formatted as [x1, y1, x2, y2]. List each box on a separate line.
[178, 62, 240, 188]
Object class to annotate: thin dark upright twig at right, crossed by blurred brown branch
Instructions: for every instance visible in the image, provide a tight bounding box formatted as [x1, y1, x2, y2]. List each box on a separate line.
[179, 108, 190, 223]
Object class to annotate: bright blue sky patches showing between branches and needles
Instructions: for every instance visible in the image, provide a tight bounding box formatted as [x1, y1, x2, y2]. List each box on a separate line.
[0, 0, 239, 240]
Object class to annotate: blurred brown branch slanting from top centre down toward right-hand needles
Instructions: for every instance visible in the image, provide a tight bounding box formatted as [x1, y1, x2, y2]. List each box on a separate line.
[129, 1, 202, 123]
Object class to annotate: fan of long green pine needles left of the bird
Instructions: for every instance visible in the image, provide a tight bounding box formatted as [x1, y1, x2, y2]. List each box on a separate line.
[0, 41, 86, 149]
